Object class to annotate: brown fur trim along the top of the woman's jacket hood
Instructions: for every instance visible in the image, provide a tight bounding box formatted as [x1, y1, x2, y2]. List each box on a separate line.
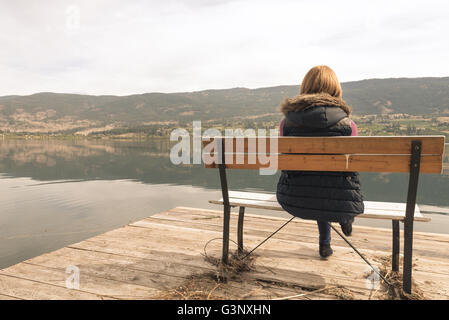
[279, 93, 352, 116]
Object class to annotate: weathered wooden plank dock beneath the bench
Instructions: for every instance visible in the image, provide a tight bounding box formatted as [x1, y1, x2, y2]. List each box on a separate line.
[0, 207, 449, 299]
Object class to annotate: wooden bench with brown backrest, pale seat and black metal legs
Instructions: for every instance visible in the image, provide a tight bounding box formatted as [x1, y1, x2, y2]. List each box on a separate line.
[203, 136, 444, 293]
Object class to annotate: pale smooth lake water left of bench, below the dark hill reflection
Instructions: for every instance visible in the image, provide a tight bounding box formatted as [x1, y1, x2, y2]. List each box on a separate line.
[0, 176, 223, 268]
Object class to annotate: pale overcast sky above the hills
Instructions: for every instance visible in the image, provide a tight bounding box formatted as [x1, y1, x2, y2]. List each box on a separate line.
[0, 0, 449, 95]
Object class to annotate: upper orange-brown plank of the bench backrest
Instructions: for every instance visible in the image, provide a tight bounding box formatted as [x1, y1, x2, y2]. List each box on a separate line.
[203, 136, 445, 155]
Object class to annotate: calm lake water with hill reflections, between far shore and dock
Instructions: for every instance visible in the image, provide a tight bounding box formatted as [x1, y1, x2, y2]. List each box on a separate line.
[0, 139, 449, 268]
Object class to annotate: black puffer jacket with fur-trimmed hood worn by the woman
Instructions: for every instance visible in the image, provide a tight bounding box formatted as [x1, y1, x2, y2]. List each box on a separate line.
[277, 94, 364, 223]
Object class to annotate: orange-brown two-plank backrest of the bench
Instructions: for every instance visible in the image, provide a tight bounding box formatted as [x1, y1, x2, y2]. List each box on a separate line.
[203, 136, 445, 173]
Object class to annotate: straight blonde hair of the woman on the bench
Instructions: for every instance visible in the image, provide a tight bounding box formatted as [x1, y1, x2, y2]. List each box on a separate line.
[299, 66, 342, 99]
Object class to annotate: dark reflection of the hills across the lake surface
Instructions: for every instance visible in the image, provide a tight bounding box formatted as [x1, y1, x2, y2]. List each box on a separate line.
[0, 139, 449, 206]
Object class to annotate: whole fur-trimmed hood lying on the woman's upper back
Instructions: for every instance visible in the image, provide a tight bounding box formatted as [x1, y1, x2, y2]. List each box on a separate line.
[279, 93, 351, 129]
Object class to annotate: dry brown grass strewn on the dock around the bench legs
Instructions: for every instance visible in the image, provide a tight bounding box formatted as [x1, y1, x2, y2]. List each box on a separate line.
[150, 239, 425, 300]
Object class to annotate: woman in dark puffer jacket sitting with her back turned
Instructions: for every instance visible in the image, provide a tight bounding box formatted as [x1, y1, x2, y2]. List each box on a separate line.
[276, 66, 364, 259]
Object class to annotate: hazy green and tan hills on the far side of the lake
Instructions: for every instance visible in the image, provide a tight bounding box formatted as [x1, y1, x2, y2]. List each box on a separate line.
[0, 77, 449, 133]
